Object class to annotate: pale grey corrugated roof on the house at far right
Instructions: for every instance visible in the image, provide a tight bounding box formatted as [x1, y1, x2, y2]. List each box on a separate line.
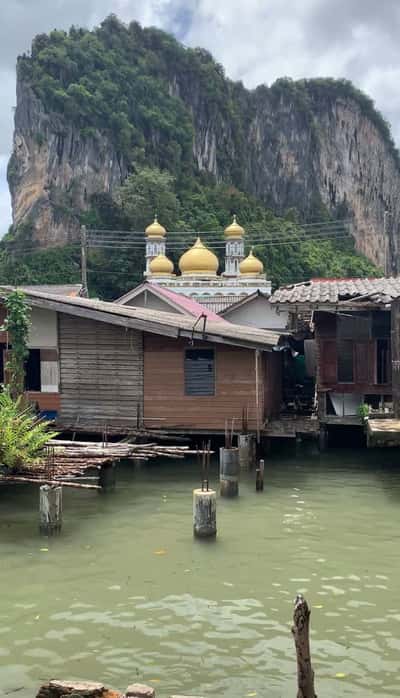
[270, 277, 400, 305]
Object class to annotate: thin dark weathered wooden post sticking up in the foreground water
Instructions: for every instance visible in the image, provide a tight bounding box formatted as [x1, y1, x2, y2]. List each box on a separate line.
[292, 594, 317, 698]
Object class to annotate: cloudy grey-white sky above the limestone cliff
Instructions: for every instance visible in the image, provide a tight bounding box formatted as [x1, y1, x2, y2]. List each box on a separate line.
[0, 0, 400, 233]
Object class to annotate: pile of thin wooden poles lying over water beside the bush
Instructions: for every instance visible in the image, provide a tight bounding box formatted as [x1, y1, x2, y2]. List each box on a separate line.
[0, 439, 212, 489]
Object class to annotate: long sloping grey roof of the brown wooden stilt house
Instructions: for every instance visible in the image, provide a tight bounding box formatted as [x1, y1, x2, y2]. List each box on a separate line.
[0, 287, 280, 349]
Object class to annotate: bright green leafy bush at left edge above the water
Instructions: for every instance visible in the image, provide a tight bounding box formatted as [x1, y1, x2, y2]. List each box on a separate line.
[0, 389, 57, 471]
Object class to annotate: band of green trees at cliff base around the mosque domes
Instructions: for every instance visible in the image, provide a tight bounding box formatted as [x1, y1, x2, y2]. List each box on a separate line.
[0, 167, 379, 300]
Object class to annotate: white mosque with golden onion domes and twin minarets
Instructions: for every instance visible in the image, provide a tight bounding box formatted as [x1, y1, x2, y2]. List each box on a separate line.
[144, 216, 271, 313]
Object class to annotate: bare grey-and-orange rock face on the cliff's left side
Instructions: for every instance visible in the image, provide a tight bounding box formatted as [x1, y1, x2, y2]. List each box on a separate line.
[8, 81, 127, 247]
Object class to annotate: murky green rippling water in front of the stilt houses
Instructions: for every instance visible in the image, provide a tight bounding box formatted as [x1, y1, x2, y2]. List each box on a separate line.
[0, 450, 400, 698]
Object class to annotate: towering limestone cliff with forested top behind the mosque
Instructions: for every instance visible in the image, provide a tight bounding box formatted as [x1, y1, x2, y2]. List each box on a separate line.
[8, 20, 400, 272]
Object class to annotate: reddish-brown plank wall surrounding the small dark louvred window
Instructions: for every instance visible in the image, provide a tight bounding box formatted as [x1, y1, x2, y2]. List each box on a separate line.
[144, 334, 265, 431]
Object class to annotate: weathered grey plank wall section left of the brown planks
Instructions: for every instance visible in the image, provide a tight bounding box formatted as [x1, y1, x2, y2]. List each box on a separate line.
[59, 313, 143, 431]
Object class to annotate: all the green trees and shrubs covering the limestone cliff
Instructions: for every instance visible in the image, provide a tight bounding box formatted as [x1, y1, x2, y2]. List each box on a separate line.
[4, 15, 384, 298]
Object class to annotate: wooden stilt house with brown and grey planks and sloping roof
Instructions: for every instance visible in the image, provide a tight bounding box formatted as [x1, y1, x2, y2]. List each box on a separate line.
[0, 291, 281, 433]
